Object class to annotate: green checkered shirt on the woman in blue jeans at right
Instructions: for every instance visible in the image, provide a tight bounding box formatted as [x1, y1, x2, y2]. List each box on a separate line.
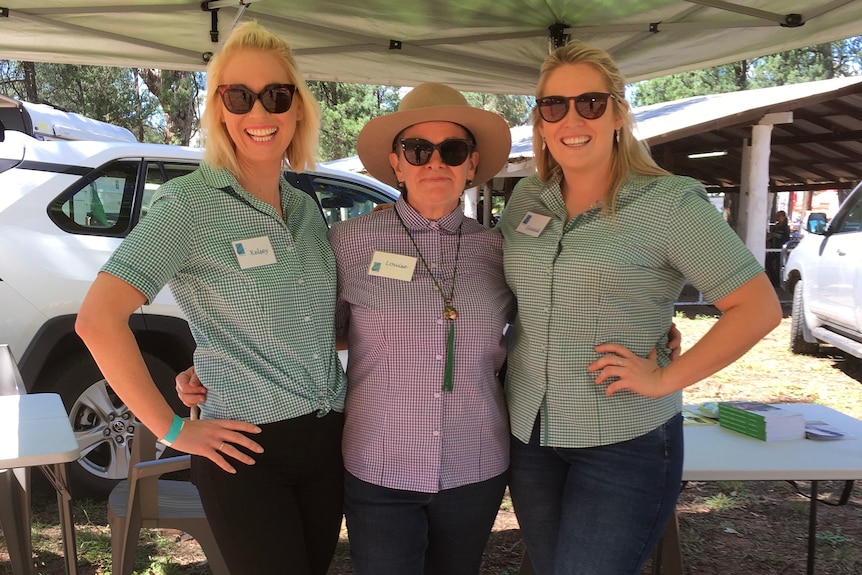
[499, 175, 762, 448]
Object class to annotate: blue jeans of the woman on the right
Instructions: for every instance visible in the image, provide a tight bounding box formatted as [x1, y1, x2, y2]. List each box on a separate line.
[509, 415, 683, 575]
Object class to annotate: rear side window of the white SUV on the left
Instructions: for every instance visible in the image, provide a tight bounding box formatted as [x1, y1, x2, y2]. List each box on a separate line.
[48, 159, 197, 237]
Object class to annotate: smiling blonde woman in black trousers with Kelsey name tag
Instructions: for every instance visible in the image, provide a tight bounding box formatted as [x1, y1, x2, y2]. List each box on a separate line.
[76, 23, 345, 575]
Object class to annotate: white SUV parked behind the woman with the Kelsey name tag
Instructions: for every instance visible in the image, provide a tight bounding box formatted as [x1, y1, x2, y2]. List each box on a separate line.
[0, 128, 398, 497]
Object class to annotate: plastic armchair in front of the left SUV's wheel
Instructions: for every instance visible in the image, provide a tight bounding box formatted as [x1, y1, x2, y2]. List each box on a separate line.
[108, 422, 230, 575]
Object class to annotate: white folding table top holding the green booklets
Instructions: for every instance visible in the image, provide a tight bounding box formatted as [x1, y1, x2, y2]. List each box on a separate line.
[682, 403, 862, 481]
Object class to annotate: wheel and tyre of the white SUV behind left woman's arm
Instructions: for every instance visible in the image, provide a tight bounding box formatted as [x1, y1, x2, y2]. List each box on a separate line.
[41, 353, 188, 499]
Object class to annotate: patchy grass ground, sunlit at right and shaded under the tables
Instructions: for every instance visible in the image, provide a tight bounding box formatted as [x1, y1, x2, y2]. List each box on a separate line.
[0, 308, 862, 575]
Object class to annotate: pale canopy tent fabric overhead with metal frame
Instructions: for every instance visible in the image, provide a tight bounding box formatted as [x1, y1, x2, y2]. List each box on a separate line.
[0, 0, 862, 94]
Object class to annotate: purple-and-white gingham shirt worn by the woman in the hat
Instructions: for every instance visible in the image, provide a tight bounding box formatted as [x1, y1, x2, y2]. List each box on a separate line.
[330, 196, 514, 493]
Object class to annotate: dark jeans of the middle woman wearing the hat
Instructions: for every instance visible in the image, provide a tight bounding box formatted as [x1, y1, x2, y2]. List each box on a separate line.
[344, 473, 506, 575]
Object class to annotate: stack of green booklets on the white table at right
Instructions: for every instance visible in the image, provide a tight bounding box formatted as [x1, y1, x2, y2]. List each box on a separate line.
[718, 401, 805, 441]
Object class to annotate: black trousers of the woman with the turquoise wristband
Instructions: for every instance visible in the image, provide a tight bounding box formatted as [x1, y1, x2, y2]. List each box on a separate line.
[192, 411, 344, 575]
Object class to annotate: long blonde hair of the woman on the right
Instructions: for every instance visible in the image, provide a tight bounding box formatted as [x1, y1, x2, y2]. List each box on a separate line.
[531, 40, 669, 208]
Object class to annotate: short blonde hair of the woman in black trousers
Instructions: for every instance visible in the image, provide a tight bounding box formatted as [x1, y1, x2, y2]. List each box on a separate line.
[201, 22, 320, 176]
